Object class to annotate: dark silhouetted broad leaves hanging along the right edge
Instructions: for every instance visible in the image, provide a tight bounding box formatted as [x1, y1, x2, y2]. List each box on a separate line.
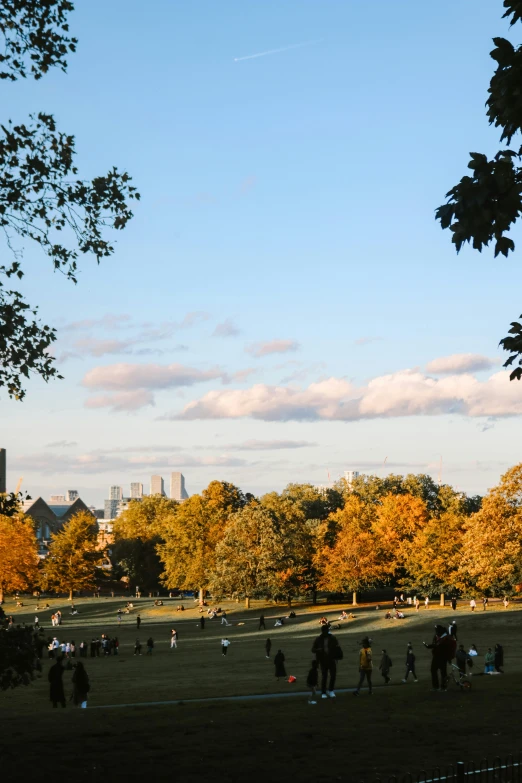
[436, 0, 522, 380]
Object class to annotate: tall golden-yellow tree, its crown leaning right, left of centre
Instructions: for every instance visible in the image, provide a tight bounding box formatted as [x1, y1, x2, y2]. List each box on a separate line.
[157, 481, 247, 598]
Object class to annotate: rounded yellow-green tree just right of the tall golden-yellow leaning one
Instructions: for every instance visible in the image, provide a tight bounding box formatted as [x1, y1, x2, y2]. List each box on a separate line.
[210, 502, 285, 608]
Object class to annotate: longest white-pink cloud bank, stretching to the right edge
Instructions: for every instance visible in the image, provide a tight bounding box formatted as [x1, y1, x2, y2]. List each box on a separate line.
[168, 370, 522, 421]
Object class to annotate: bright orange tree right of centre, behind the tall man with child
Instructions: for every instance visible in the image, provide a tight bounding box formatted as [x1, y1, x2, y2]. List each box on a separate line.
[315, 495, 385, 604]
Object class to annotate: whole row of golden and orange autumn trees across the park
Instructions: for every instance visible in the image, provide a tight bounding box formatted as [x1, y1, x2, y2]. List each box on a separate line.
[0, 464, 522, 603]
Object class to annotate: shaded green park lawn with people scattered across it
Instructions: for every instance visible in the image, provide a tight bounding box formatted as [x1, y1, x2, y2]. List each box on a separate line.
[0, 598, 522, 781]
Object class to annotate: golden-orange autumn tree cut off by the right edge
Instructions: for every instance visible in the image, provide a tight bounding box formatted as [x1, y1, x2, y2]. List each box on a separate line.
[459, 463, 522, 594]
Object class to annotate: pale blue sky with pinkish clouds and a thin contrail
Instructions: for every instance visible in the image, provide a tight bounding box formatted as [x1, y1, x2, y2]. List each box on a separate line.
[0, 0, 522, 504]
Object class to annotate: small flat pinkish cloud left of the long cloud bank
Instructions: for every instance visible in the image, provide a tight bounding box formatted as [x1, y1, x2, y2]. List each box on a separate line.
[82, 362, 224, 391]
